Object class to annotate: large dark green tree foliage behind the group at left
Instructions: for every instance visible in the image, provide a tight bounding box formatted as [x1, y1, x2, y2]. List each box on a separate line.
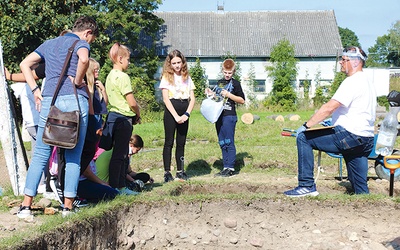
[0, 0, 163, 110]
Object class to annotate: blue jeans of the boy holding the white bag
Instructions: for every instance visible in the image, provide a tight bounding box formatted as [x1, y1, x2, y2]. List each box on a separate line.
[215, 115, 237, 169]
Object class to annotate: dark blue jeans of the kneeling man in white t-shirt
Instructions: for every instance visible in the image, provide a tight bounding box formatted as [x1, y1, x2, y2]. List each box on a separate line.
[297, 126, 374, 194]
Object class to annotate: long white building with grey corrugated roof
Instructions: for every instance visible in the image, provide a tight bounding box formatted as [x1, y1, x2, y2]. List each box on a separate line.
[155, 10, 342, 99]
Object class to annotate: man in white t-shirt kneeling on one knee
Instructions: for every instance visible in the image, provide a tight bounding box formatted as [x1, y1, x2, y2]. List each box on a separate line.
[284, 47, 376, 197]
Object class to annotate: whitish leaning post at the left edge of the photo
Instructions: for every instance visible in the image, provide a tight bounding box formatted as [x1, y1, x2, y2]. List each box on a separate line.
[0, 41, 28, 196]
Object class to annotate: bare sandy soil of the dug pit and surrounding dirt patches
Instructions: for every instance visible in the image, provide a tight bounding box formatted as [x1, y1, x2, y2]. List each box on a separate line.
[0, 148, 400, 250]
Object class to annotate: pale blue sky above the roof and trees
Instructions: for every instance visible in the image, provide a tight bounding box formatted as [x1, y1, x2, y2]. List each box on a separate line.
[157, 0, 400, 51]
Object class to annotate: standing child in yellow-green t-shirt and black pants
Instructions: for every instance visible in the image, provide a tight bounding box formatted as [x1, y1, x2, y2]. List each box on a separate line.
[100, 43, 141, 195]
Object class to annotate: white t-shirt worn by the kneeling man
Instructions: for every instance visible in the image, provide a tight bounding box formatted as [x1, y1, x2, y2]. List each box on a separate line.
[332, 71, 376, 137]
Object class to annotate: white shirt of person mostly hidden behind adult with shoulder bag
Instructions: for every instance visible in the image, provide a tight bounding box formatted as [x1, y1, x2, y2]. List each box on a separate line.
[10, 82, 39, 127]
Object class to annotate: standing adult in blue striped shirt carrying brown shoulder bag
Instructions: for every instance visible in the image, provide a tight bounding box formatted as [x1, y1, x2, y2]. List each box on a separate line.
[17, 16, 99, 218]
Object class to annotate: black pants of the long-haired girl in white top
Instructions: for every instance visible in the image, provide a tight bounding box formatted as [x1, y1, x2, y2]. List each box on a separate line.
[163, 99, 189, 171]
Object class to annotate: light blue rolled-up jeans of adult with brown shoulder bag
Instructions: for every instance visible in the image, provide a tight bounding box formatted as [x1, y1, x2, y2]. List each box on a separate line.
[24, 95, 89, 198]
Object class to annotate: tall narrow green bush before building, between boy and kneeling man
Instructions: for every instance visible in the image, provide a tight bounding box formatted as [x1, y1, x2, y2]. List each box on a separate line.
[266, 39, 298, 111]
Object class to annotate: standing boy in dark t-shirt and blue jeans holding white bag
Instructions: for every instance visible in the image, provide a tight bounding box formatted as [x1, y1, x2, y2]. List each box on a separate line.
[211, 59, 245, 177]
